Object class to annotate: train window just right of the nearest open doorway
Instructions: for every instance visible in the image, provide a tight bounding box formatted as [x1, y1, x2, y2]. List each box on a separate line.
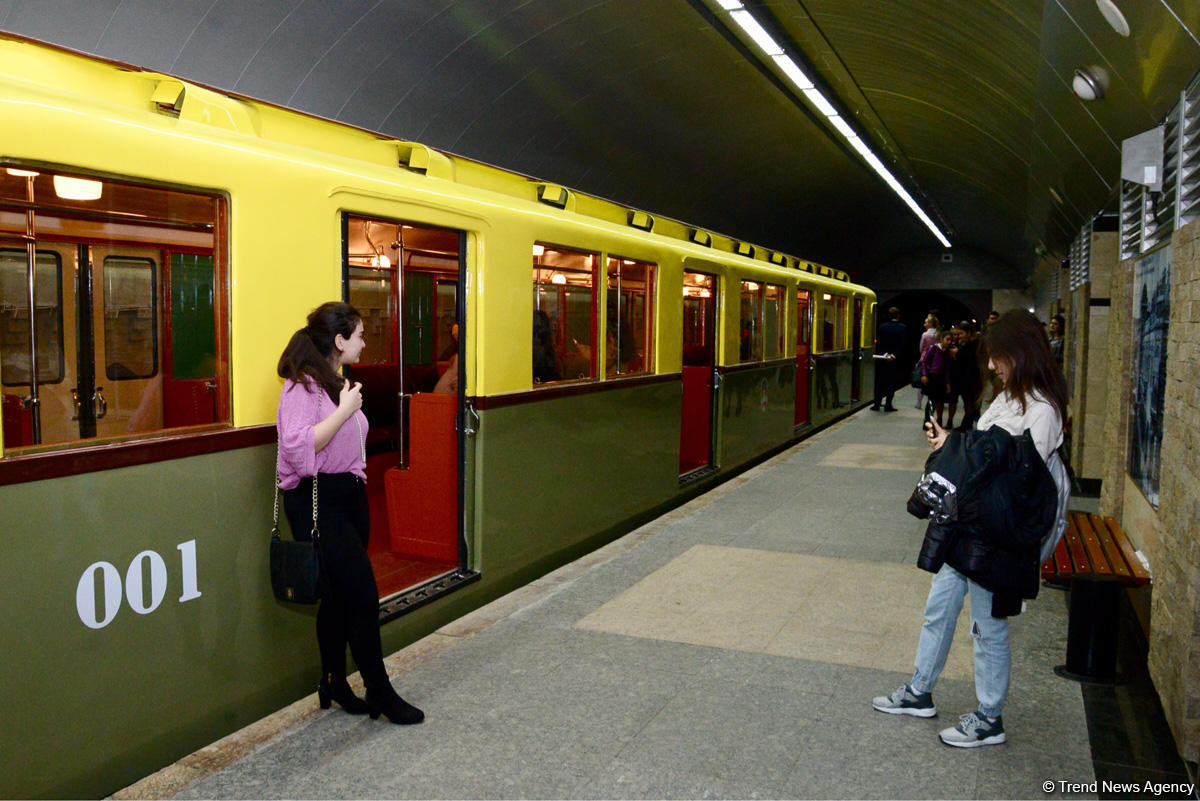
[530, 240, 601, 389]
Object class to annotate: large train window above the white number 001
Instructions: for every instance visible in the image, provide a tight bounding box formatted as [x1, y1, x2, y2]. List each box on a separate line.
[0, 164, 233, 460]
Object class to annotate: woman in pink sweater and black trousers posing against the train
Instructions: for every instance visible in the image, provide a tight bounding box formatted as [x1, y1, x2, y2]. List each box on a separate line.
[276, 302, 425, 723]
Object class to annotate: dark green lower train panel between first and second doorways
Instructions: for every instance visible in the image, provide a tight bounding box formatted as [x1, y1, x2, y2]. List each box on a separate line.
[474, 381, 683, 580]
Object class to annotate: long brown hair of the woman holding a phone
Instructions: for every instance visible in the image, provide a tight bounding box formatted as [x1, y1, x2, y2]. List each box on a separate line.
[983, 309, 1067, 422]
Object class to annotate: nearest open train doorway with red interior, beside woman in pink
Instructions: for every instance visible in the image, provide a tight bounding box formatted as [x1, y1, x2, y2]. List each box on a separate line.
[343, 215, 466, 606]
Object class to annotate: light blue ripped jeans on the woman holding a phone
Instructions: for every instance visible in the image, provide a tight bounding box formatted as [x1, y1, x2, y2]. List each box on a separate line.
[911, 565, 1013, 717]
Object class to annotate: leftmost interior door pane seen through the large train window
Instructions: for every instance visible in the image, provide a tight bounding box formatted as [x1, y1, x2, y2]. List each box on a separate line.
[0, 248, 62, 386]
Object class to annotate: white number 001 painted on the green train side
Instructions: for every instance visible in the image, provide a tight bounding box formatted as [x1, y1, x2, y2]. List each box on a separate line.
[76, 540, 200, 628]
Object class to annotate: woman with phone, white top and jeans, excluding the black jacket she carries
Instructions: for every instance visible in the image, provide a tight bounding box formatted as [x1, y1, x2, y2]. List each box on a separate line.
[871, 309, 1069, 748]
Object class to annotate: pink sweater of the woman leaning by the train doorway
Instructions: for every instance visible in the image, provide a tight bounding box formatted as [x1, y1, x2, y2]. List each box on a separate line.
[275, 379, 367, 489]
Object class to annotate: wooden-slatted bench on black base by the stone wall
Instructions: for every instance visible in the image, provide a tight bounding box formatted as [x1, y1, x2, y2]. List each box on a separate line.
[1042, 512, 1150, 683]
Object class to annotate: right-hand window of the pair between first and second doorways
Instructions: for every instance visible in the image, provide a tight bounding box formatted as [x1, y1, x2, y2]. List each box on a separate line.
[605, 257, 654, 378]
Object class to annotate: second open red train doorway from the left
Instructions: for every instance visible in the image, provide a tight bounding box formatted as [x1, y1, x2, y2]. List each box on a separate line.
[679, 271, 716, 476]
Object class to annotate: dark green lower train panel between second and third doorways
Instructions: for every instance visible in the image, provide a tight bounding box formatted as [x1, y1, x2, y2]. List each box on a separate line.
[718, 361, 796, 470]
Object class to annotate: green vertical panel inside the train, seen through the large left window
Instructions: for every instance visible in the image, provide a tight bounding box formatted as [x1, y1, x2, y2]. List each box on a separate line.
[170, 253, 216, 379]
